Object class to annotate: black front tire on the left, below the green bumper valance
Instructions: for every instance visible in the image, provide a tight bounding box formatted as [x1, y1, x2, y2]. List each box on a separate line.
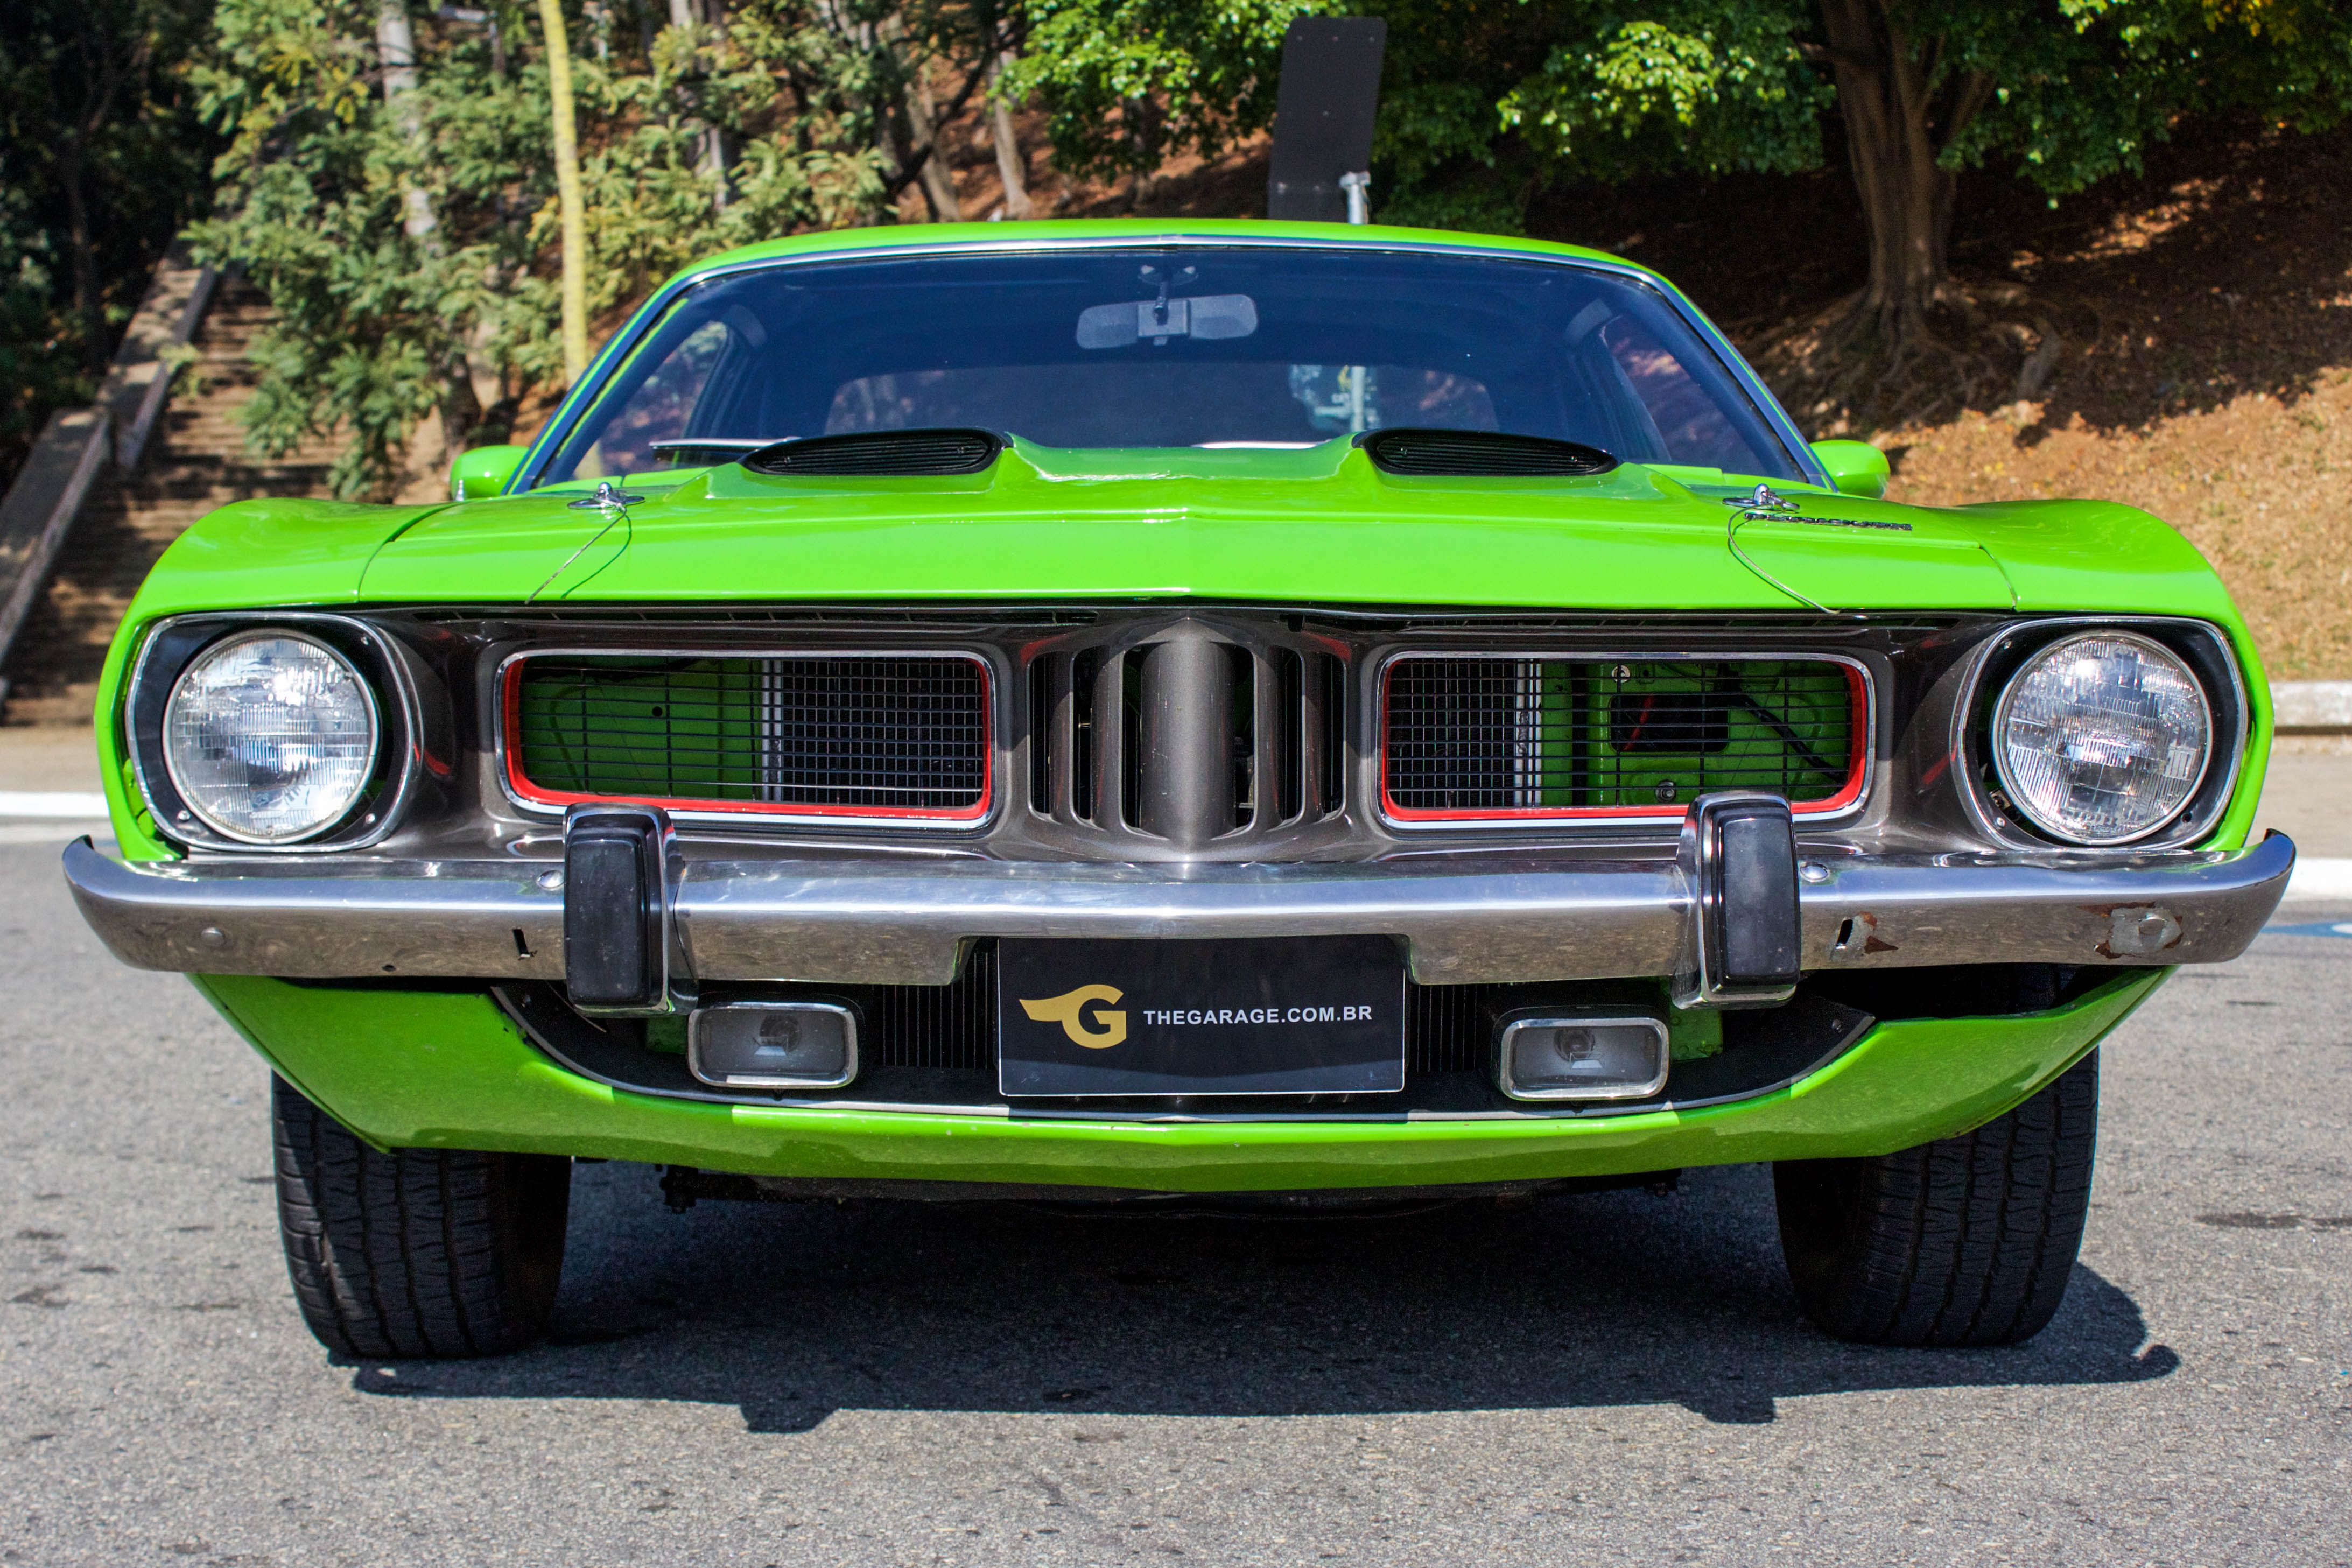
[270, 1079, 572, 1359]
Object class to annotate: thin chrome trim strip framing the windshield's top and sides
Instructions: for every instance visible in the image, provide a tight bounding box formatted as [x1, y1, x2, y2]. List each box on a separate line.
[501, 228, 1837, 494]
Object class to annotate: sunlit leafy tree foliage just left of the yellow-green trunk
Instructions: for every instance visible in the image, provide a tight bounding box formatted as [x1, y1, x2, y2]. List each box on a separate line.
[193, 0, 548, 494]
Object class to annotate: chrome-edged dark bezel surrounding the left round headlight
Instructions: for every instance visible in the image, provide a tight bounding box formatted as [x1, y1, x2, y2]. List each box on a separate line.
[120, 611, 447, 856]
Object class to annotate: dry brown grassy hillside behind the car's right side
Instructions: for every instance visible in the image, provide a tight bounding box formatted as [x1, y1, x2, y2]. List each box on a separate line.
[1534, 115, 2352, 679]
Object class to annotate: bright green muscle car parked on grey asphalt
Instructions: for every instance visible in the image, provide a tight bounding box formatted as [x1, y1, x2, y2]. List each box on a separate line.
[66, 221, 2293, 1356]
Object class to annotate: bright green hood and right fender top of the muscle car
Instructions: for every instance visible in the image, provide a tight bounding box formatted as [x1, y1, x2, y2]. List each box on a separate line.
[336, 440, 2227, 614]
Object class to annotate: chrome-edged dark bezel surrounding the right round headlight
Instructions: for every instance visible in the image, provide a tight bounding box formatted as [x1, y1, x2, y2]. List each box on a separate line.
[1952, 616, 2251, 856]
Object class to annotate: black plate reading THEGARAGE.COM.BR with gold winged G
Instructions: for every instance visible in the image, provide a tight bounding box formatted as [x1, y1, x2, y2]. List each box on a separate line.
[997, 936, 1404, 1095]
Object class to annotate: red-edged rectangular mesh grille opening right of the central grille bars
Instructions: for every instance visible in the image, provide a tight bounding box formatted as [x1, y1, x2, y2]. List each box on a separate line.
[1383, 658, 1856, 813]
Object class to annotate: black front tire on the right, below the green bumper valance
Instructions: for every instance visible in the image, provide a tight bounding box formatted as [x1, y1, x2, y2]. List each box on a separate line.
[1773, 1051, 2098, 1345]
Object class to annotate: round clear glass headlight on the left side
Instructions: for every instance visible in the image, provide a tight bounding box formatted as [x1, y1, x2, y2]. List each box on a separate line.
[162, 632, 376, 844]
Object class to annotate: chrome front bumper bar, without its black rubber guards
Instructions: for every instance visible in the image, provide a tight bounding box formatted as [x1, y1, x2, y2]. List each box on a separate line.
[66, 834, 2295, 985]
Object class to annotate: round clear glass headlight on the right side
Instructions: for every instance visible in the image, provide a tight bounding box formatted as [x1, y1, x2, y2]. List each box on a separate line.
[1992, 632, 2213, 844]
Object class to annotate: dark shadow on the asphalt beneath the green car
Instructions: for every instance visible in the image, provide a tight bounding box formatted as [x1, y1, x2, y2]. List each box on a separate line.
[353, 1164, 2180, 1432]
